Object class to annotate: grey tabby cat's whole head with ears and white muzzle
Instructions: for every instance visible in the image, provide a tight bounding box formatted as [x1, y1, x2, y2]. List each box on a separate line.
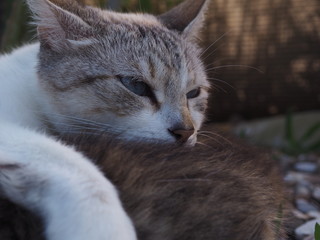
[28, 0, 209, 144]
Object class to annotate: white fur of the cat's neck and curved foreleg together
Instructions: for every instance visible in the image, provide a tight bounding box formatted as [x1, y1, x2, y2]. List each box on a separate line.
[0, 44, 136, 240]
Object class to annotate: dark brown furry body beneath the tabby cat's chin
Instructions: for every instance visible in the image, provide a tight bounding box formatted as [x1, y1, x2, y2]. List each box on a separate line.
[0, 132, 288, 240]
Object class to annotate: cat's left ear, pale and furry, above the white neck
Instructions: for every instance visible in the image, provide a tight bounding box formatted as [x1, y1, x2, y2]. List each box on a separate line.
[27, 0, 92, 52]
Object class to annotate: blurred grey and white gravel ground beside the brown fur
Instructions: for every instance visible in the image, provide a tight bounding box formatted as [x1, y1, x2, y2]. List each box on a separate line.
[274, 151, 320, 240]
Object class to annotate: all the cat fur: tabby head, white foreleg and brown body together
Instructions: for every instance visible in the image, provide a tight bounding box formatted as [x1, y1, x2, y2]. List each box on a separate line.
[0, 0, 288, 240]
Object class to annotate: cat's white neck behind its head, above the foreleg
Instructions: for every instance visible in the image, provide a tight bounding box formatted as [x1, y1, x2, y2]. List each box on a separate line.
[0, 43, 43, 129]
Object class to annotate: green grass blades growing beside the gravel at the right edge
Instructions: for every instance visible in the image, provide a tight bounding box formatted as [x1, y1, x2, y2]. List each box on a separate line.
[282, 111, 320, 155]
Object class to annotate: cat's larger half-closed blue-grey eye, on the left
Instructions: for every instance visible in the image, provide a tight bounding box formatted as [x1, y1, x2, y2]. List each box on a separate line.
[119, 76, 153, 97]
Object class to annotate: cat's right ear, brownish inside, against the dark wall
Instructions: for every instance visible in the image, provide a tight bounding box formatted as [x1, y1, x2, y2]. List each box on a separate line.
[158, 0, 209, 38]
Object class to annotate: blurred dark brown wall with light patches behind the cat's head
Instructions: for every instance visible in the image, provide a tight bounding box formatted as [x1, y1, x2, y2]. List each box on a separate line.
[0, 0, 320, 121]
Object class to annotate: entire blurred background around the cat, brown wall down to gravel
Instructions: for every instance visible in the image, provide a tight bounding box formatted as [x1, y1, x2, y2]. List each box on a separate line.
[0, 0, 320, 236]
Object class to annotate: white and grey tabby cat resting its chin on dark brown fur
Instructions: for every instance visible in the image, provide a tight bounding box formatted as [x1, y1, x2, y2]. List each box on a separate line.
[0, 0, 209, 240]
